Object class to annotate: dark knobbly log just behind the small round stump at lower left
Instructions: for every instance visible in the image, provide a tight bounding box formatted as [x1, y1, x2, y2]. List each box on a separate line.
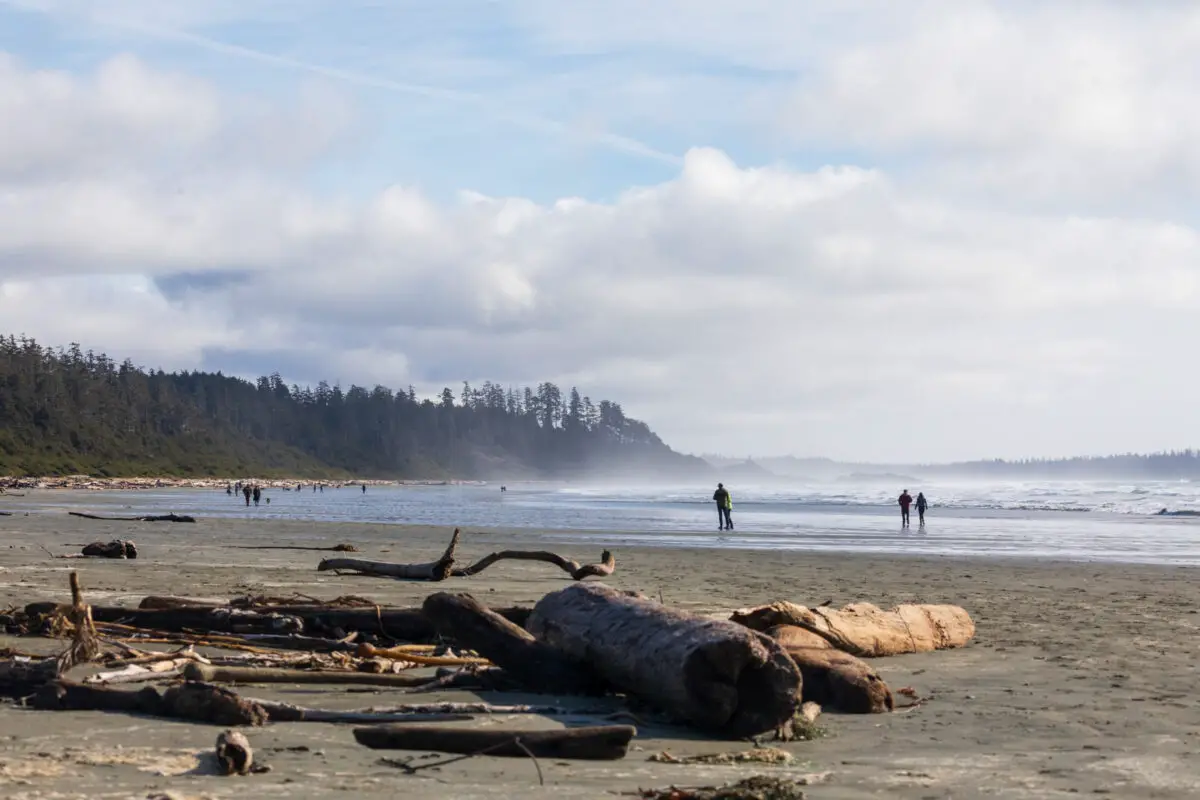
[32, 680, 268, 726]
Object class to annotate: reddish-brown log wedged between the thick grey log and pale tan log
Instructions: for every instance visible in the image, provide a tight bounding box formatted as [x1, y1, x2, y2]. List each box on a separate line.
[767, 625, 895, 714]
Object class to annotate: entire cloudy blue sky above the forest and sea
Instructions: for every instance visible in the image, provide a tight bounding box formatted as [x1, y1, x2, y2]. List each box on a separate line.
[0, 0, 1200, 462]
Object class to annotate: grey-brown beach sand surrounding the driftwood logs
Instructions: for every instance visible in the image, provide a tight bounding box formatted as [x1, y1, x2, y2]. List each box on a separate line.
[0, 512, 1200, 800]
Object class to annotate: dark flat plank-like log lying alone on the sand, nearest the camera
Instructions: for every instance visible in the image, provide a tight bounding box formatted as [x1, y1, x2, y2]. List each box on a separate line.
[354, 724, 637, 760]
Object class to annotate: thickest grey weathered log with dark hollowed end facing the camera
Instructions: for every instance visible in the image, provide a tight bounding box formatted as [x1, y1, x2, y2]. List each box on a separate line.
[528, 583, 802, 738]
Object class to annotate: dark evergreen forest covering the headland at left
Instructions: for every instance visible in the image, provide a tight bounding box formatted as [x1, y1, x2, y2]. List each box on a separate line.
[0, 336, 709, 480]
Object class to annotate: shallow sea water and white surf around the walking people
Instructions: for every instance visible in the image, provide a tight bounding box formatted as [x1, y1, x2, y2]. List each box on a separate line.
[9, 481, 1200, 565]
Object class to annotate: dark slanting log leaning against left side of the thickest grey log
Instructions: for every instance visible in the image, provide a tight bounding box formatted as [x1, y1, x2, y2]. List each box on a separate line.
[421, 593, 605, 694]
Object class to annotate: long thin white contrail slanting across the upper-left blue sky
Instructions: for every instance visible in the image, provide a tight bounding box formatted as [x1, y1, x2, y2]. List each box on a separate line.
[0, 0, 683, 167]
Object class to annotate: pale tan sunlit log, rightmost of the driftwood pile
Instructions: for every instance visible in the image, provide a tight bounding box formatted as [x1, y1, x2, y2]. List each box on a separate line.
[730, 602, 974, 658]
